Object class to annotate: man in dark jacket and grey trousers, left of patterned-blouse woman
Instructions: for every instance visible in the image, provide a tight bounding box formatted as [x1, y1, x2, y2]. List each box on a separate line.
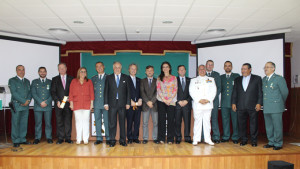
[141, 65, 159, 144]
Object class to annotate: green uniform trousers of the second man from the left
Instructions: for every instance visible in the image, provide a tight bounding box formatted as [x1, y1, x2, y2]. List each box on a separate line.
[34, 110, 52, 140]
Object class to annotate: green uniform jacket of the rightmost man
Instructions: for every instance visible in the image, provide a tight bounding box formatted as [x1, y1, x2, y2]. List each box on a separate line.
[263, 73, 289, 113]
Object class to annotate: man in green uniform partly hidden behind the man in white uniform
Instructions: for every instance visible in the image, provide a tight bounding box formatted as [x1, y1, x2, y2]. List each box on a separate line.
[202, 60, 221, 144]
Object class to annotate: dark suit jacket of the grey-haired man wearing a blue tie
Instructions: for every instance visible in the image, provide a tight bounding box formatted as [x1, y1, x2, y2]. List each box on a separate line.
[104, 73, 131, 107]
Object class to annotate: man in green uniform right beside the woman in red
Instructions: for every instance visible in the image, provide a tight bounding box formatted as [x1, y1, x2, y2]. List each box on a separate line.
[92, 62, 109, 145]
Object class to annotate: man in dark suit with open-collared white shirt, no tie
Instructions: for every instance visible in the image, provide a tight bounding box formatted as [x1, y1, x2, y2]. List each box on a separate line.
[231, 63, 263, 147]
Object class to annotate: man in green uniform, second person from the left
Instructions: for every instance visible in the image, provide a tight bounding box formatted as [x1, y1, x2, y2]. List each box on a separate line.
[31, 67, 53, 144]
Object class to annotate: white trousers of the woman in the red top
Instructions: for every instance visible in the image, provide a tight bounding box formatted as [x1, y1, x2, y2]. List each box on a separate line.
[74, 110, 90, 142]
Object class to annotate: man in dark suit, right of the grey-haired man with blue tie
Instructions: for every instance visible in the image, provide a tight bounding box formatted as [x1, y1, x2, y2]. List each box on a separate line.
[126, 63, 142, 144]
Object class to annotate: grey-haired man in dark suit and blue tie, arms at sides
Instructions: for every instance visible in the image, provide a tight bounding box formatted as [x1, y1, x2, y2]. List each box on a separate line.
[104, 62, 130, 147]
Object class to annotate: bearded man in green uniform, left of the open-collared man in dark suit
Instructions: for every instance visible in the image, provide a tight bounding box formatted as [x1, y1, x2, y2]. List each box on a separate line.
[221, 61, 240, 144]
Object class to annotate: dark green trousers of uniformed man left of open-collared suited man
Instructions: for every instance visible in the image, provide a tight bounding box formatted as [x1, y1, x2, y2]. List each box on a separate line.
[221, 107, 239, 140]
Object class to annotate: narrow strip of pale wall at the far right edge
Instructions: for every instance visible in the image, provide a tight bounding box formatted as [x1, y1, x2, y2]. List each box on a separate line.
[291, 40, 300, 88]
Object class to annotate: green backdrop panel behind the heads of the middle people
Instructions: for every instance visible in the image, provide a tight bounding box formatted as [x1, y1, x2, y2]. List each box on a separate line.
[81, 52, 189, 78]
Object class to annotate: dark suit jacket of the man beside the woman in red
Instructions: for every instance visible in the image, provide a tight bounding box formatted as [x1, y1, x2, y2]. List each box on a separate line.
[51, 75, 73, 107]
